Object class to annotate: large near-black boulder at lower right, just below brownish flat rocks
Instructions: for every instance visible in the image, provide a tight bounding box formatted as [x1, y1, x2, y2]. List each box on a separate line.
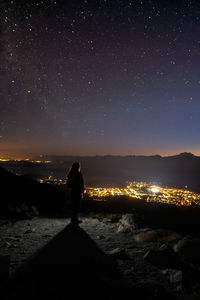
[144, 249, 182, 270]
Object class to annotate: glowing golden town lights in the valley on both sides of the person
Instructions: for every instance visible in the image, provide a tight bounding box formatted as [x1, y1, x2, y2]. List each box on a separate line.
[39, 176, 200, 206]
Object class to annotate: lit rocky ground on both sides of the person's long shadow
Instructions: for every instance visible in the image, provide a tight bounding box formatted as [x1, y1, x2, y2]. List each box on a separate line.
[0, 214, 199, 299]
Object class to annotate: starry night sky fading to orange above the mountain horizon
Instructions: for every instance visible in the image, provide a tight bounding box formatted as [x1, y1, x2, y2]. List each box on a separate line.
[0, 0, 200, 157]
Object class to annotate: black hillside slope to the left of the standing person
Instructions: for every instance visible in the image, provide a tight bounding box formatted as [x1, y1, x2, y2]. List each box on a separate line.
[0, 167, 65, 217]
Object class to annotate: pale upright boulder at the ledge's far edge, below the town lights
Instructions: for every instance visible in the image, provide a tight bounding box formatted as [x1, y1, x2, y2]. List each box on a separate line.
[117, 214, 138, 233]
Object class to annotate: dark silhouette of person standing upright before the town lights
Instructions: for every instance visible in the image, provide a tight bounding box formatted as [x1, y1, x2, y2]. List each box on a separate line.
[67, 162, 84, 223]
